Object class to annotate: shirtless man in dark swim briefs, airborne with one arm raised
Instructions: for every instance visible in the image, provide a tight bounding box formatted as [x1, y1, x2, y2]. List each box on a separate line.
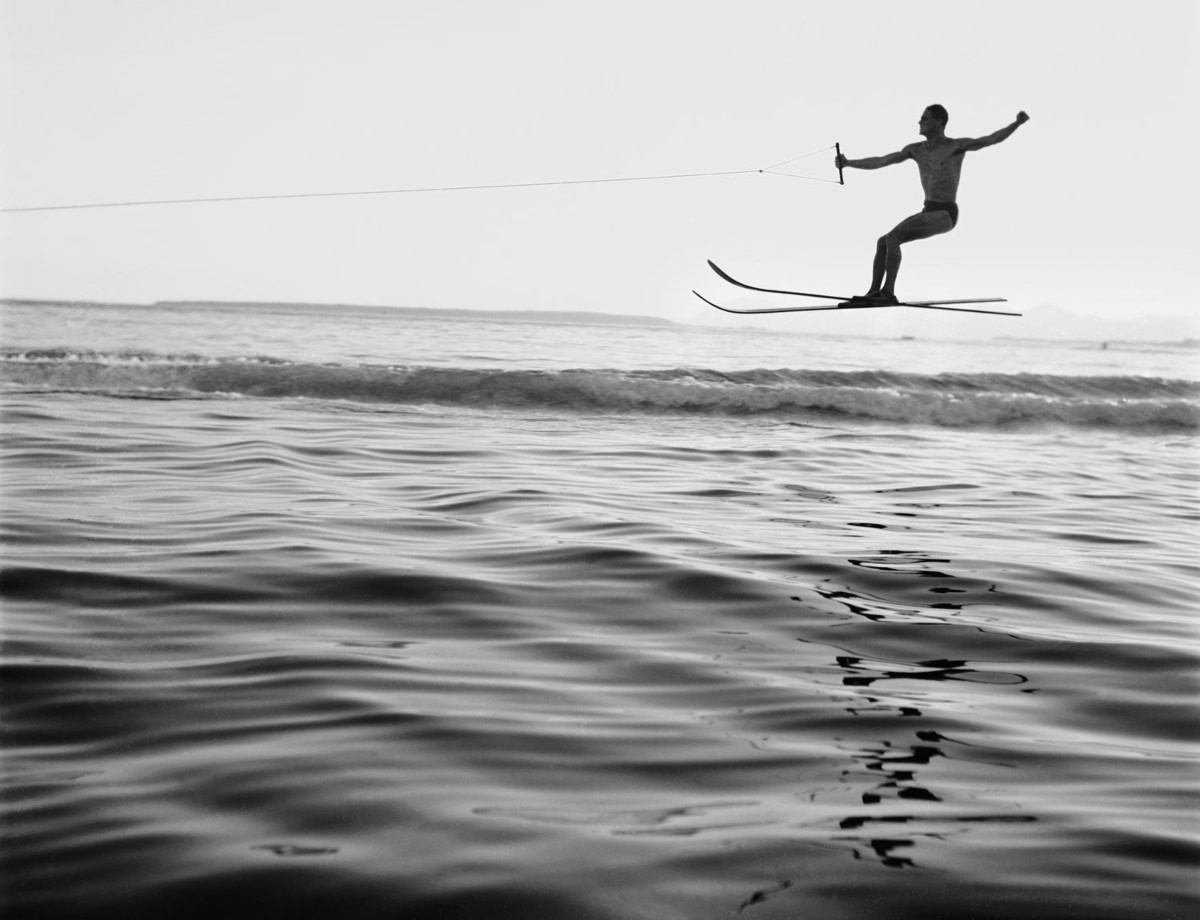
[835, 106, 1030, 305]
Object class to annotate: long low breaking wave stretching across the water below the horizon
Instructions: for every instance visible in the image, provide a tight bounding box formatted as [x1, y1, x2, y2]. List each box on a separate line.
[0, 349, 1200, 431]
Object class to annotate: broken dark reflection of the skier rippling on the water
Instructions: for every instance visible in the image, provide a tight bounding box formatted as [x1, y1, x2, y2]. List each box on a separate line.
[793, 551, 1037, 870]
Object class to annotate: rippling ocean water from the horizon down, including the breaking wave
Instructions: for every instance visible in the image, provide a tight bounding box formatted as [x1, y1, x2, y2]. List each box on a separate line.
[0, 303, 1200, 920]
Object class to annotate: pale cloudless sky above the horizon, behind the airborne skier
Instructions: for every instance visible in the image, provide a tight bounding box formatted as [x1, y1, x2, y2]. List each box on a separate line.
[0, 0, 1200, 327]
